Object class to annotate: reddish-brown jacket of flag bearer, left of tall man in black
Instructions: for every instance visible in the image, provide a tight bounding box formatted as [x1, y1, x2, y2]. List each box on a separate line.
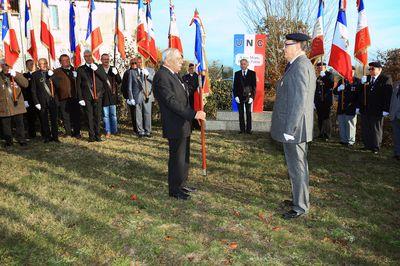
[54, 67, 77, 101]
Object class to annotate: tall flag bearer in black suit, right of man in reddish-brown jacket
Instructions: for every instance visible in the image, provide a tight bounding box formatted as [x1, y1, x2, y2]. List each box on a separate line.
[76, 50, 110, 142]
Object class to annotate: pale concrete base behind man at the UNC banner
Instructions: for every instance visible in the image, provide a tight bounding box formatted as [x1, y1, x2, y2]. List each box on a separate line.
[206, 111, 272, 132]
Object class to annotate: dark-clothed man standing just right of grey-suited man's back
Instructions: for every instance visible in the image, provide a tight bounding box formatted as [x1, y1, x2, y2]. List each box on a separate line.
[314, 62, 334, 140]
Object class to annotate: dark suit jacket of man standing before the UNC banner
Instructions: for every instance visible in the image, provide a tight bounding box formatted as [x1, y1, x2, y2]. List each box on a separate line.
[233, 69, 257, 102]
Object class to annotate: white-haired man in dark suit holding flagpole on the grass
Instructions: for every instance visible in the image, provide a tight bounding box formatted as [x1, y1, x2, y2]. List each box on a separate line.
[153, 48, 206, 200]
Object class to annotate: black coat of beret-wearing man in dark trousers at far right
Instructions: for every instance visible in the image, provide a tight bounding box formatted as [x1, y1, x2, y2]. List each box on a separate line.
[357, 73, 393, 117]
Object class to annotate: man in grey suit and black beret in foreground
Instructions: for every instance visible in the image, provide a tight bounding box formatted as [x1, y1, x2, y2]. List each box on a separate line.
[271, 33, 316, 219]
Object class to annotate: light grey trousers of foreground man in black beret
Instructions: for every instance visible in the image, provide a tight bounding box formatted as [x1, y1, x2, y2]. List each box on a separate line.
[283, 142, 310, 213]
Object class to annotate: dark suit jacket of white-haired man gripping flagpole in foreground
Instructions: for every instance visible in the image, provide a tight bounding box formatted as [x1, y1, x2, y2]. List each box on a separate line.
[153, 66, 196, 139]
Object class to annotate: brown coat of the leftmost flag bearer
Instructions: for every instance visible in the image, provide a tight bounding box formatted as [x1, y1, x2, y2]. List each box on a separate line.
[0, 72, 29, 117]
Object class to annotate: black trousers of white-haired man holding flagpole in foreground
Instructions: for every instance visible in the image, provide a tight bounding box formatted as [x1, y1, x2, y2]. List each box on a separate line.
[168, 137, 190, 193]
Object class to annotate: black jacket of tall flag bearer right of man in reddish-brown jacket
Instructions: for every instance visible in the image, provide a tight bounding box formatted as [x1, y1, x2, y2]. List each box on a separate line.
[76, 64, 108, 101]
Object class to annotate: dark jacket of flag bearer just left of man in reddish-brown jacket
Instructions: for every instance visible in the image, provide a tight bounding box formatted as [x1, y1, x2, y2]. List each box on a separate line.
[32, 70, 58, 108]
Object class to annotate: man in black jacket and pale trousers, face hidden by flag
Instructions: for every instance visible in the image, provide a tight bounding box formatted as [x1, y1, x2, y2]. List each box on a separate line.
[333, 66, 361, 147]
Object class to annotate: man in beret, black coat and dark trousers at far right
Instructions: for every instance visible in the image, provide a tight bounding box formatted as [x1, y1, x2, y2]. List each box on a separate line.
[356, 62, 393, 154]
